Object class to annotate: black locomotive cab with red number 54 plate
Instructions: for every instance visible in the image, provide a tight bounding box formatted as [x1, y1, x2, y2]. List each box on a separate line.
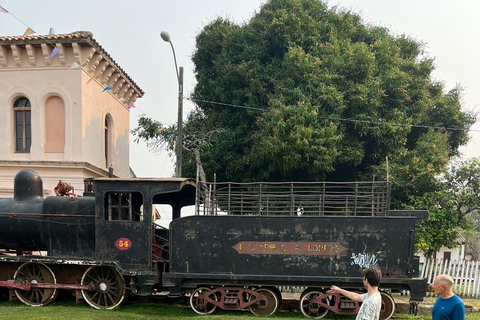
[94, 178, 195, 271]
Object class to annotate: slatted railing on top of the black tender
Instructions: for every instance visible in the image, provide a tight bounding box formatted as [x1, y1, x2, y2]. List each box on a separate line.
[197, 181, 391, 216]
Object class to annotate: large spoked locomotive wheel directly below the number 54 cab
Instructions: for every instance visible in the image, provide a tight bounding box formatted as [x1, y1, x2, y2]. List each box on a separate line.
[82, 266, 127, 309]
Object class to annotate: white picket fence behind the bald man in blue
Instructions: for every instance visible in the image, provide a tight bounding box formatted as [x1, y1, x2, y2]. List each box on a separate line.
[421, 259, 480, 298]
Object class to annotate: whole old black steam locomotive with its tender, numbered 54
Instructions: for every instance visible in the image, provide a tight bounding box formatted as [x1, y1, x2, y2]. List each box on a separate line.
[0, 170, 427, 319]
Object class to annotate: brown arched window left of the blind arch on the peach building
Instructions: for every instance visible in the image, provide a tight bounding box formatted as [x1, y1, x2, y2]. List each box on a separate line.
[13, 97, 32, 152]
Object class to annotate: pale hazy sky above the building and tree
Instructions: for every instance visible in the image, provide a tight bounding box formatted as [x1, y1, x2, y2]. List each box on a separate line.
[0, 0, 480, 177]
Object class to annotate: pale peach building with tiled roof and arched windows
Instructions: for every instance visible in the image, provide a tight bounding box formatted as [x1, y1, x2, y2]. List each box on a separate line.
[0, 31, 144, 197]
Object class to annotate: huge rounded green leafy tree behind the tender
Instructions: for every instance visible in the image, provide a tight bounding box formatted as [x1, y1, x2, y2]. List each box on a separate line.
[133, 0, 475, 207]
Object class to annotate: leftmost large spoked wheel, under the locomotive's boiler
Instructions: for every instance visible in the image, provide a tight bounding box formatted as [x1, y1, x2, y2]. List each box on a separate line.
[14, 262, 58, 307]
